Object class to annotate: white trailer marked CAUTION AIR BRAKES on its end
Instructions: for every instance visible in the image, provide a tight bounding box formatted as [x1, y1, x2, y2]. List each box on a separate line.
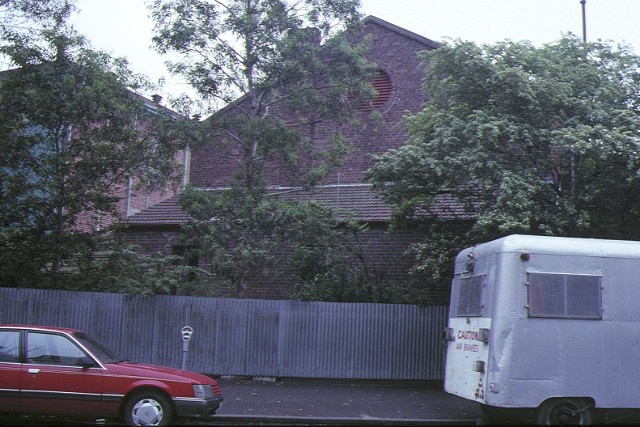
[444, 235, 640, 424]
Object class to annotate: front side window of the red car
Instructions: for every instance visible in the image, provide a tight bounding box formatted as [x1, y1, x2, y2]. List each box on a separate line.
[27, 332, 87, 366]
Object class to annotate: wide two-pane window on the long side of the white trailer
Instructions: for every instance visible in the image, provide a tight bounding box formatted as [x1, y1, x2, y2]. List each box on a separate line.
[529, 273, 602, 319]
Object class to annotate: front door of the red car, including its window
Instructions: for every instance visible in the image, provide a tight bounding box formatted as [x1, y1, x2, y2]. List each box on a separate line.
[20, 331, 102, 417]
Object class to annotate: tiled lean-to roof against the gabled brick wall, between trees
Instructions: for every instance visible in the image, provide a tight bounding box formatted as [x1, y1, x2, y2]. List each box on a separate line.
[125, 184, 471, 226]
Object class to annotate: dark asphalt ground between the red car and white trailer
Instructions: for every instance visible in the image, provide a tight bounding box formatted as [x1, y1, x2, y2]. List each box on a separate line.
[0, 378, 482, 426]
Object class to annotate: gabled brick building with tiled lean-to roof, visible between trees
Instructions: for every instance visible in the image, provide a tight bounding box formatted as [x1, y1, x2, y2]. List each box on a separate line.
[120, 16, 456, 303]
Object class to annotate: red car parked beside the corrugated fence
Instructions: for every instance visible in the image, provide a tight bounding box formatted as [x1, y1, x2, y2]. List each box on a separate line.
[0, 325, 222, 425]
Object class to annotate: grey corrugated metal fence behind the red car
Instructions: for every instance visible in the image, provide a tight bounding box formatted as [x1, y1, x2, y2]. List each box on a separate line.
[0, 288, 447, 380]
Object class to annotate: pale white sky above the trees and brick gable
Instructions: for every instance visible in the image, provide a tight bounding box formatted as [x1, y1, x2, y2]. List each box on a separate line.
[72, 0, 640, 96]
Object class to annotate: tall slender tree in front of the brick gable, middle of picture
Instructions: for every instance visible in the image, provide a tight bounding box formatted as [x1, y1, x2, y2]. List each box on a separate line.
[152, 0, 377, 296]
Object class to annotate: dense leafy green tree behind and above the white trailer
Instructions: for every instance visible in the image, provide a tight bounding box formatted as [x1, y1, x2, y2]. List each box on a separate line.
[368, 35, 640, 280]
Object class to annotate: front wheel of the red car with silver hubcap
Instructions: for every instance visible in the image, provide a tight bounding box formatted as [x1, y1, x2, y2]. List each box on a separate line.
[124, 391, 173, 426]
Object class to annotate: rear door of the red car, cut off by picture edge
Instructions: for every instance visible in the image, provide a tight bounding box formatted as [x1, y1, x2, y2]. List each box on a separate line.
[0, 329, 20, 412]
